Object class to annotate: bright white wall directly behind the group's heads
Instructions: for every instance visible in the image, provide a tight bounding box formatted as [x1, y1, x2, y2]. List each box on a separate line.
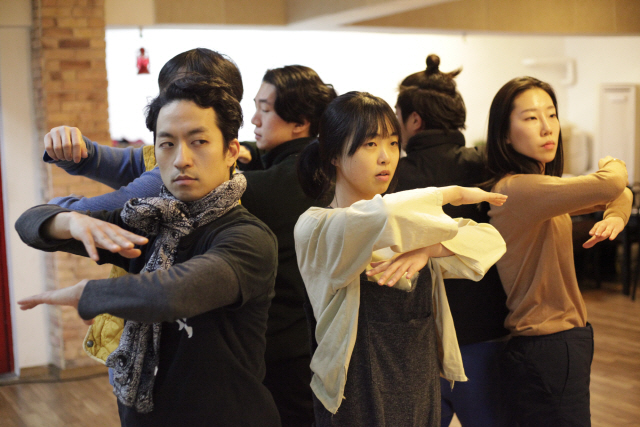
[106, 29, 564, 147]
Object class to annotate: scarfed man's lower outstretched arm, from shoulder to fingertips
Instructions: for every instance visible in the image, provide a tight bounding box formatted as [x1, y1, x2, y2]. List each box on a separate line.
[18, 224, 277, 323]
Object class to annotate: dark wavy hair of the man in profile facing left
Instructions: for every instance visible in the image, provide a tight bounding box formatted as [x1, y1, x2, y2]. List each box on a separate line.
[262, 65, 336, 136]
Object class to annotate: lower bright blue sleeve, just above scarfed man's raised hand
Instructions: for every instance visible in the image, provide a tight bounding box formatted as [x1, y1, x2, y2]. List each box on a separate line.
[49, 167, 162, 211]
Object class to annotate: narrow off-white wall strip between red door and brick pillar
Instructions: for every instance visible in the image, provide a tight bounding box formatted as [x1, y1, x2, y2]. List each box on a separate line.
[0, 26, 49, 372]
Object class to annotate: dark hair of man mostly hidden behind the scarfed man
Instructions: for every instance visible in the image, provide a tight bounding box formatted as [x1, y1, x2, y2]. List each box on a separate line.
[158, 47, 244, 102]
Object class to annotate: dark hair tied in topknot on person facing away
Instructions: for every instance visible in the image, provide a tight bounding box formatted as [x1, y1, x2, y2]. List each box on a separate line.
[397, 54, 467, 131]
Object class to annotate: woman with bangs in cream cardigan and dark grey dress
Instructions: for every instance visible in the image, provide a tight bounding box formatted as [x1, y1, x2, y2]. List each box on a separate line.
[294, 92, 506, 427]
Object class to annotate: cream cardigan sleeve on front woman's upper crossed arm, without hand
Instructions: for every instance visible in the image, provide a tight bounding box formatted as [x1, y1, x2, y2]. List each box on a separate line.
[294, 188, 457, 302]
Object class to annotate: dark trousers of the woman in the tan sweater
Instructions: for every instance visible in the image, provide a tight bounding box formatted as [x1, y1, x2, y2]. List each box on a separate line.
[502, 324, 593, 427]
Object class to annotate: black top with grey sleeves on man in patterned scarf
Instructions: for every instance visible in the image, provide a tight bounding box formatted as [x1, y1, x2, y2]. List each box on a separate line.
[16, 205, 280, 427]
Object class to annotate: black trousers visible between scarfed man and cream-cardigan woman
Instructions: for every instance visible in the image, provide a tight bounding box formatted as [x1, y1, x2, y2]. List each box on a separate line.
[262, 356, 314, 427]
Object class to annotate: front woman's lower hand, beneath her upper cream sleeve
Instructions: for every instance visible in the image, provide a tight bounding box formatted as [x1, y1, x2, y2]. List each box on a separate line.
[366, 243, 453, 286]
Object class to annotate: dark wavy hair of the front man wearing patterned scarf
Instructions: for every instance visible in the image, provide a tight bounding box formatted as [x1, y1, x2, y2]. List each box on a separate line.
[147, 75, 242, 152]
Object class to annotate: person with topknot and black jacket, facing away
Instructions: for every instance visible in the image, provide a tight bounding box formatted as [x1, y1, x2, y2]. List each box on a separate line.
[396, 54, 509, 427]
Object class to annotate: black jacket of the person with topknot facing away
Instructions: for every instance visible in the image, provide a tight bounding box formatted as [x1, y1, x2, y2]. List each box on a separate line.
[396, 130, 508, 345]
